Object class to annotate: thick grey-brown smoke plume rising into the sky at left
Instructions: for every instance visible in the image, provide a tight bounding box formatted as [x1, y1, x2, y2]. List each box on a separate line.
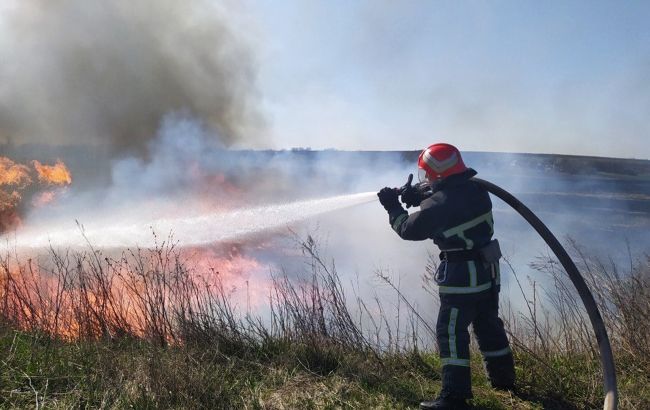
[0, 0, 260, 155]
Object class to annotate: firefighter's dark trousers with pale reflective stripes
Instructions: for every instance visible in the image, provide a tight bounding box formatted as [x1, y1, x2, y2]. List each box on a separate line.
[436, 291, 515, 398]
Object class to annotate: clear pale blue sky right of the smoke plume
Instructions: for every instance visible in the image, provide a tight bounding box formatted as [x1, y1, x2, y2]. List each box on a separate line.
[240, 0, 650, 159]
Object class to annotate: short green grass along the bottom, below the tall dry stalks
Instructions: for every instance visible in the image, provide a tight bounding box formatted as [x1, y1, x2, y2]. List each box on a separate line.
[0, 329, 598, 409]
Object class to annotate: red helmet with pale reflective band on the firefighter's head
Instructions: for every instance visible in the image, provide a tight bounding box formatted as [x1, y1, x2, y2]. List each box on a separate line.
[418, 144, 467, 181]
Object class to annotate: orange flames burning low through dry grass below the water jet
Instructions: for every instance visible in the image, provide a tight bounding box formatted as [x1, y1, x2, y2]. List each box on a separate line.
[0, 245, 271, 343]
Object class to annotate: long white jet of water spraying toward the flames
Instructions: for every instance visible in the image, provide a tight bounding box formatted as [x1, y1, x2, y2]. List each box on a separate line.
[0, 192, 376, 250]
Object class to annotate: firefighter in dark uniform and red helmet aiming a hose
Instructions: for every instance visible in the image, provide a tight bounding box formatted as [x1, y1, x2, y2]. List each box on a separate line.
[377, 144, 515, 409]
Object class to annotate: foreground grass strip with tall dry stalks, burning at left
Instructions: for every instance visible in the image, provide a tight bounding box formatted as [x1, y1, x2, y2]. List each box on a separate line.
[0, 238, 650, 409]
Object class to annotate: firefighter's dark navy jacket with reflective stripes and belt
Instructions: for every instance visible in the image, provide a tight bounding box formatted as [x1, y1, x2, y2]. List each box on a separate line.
[389, 169, 499, 294]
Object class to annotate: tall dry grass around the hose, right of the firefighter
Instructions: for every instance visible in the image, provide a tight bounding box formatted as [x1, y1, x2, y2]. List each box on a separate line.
[504, 240, 650, 409]
